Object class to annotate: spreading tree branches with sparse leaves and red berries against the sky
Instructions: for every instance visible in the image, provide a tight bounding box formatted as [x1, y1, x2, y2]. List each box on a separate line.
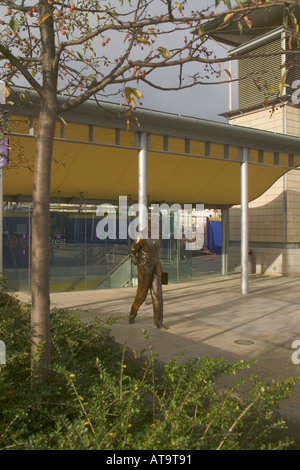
[0, 0, 297, 108]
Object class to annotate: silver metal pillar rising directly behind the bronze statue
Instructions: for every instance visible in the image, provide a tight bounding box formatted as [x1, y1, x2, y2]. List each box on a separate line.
[138, 132, 148, 232]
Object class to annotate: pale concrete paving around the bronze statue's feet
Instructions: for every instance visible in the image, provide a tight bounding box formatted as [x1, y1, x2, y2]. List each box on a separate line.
[19, 274, 300, 442]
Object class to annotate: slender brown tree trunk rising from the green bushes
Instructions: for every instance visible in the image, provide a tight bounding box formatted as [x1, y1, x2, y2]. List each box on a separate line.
[31, 94, 57, 382]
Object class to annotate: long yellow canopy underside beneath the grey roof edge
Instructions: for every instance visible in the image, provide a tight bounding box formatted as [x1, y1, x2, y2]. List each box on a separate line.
[4, 106, 300, 205]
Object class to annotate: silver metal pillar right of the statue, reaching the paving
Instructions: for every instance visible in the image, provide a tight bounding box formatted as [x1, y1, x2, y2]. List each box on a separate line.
[241, 148, 249, 294]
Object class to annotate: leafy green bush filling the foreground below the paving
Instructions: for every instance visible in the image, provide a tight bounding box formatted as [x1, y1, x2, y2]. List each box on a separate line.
[0, 294, 296, 450]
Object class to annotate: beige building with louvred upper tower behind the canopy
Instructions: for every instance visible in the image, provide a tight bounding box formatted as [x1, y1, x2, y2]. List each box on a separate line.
[224, 23, 300, 276]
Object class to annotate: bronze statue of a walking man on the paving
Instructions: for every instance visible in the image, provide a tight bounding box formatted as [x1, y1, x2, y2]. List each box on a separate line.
[129, 218, 167, 329]
